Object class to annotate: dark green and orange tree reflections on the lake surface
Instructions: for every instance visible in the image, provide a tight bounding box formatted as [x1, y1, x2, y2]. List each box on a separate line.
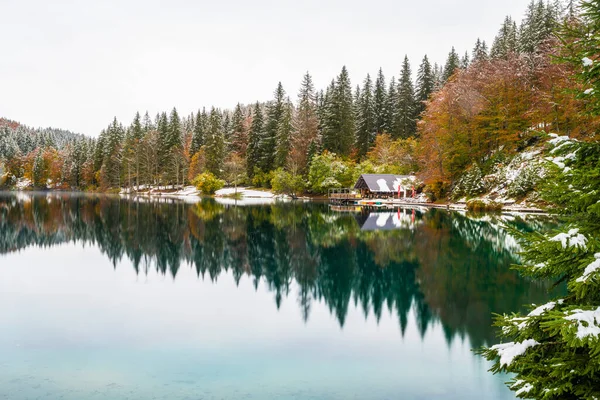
[0, 194, 546, 346]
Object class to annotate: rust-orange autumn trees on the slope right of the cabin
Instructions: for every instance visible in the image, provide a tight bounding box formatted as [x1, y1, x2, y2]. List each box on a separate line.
[418, 41, 599, 198]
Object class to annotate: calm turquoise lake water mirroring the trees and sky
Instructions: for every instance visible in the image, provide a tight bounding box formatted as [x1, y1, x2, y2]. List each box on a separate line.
[0, 194, 551, 400]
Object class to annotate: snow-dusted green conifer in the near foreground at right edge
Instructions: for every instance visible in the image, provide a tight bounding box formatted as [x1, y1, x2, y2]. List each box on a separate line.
[480, 0, 600, 400]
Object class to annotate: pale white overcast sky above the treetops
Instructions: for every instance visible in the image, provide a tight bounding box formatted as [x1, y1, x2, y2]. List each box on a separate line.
[0, 0, 528, 136]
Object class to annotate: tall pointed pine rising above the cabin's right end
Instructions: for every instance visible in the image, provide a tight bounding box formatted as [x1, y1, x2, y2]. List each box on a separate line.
[394, 56, 419, 138]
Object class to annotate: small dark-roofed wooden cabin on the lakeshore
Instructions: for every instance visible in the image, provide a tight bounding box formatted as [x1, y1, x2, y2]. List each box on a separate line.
[354, 174, 414, 199]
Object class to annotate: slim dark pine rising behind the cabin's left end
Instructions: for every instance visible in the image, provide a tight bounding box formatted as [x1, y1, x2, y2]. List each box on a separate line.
[355, 74, 375, 158]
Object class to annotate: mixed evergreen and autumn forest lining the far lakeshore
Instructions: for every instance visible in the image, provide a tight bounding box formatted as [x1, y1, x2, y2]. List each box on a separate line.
[0, 0, 600, 200]
